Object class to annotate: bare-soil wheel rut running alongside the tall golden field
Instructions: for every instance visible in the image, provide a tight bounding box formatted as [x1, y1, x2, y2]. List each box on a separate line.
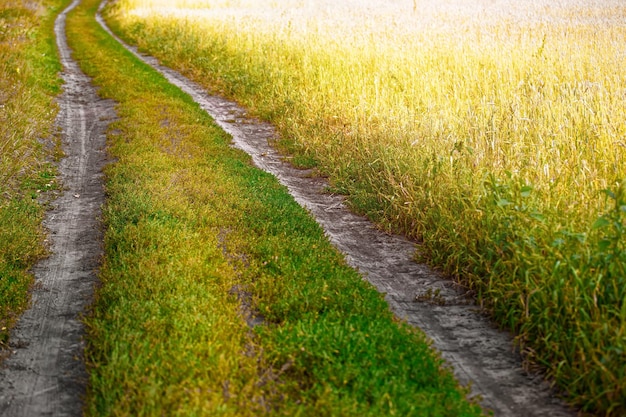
[98, 4, 576, 417]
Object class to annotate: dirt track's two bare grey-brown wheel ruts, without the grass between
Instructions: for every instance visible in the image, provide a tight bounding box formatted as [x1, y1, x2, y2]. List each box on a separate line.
[0, 0, 574, 417]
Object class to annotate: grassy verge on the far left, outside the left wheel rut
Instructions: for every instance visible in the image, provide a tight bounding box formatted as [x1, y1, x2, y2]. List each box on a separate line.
[0, 0, 67, 349]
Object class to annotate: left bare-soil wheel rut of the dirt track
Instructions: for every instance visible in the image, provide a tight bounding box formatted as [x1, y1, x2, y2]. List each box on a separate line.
[0, 0, 115, 417]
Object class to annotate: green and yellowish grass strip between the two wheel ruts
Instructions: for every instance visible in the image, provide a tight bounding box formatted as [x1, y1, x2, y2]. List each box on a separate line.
[67, 0, 481, 416]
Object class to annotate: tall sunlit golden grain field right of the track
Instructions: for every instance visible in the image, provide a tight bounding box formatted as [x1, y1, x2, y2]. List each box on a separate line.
[107, 0, 626, 415]
